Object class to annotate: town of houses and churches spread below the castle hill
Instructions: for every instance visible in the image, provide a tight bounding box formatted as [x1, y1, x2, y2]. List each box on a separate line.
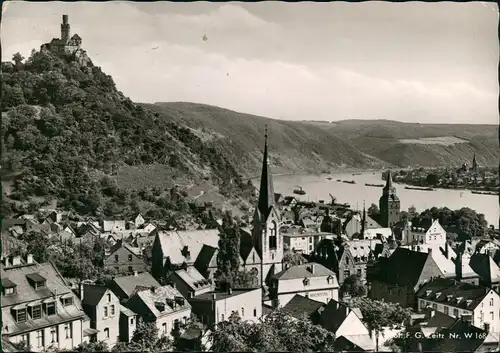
[1, 126, 500, 352]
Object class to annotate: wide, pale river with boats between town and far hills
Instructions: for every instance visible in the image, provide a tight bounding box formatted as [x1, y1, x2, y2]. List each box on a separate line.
[274, 172, 500, 227]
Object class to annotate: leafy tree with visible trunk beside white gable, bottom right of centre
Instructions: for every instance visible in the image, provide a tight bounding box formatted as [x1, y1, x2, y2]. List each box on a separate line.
[351, 297, 411, 351]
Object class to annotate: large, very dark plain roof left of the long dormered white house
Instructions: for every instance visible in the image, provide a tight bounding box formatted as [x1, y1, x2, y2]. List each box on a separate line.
[376, 248, 443, 287]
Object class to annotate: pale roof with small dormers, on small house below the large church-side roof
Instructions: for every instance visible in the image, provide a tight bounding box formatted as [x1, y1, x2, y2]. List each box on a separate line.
[136, 286, 191, 317]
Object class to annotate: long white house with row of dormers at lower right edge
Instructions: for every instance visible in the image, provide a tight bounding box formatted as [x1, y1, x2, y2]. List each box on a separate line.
[417, 278, 500, 332]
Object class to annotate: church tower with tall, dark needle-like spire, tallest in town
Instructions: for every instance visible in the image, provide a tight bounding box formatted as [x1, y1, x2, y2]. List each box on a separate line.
[252, 127, 283, 284]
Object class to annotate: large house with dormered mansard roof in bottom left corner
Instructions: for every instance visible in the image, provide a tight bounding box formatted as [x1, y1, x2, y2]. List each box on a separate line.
[1, 255, 93, 352]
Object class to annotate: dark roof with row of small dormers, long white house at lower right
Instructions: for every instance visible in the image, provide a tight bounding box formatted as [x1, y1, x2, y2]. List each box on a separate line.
[417, 278, 490, 310]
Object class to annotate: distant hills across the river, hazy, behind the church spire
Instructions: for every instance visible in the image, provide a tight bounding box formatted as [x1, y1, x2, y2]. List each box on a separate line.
[144, 102, 499, 175]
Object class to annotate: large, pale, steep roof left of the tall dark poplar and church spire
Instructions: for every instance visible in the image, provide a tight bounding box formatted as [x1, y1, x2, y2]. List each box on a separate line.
[157, 229, 219, 264]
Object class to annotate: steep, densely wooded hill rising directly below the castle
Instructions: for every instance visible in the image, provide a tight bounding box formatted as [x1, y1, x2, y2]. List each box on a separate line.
[1, 50, 245, 215]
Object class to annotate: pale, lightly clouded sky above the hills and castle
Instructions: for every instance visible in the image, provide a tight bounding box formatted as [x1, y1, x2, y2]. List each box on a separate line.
[1, 1, 499, 124]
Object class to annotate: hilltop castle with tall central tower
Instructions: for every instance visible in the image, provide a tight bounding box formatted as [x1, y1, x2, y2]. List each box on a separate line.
[41, 15, 89, 64]
